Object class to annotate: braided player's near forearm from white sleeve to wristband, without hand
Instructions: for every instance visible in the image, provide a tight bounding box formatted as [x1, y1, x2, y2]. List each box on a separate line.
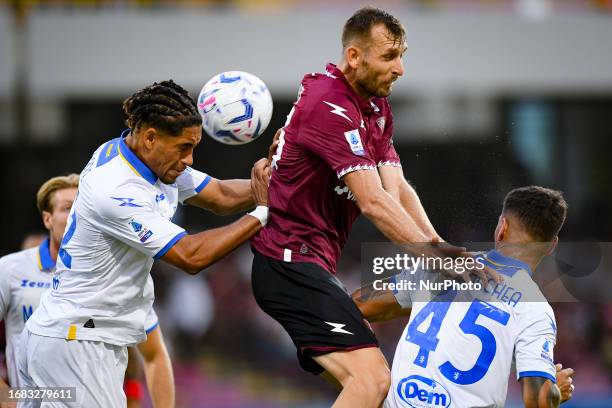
[161, 214, 262, 275]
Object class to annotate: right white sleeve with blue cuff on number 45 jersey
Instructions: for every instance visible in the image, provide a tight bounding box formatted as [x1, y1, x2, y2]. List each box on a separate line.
[514, 304, 557, 382]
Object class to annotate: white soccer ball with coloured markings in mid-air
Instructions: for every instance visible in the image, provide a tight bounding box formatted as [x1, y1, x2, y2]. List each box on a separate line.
[198, 71, 272, 145]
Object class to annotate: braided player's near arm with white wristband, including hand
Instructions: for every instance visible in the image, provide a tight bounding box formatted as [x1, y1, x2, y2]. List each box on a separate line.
[161, 159, 269, 275]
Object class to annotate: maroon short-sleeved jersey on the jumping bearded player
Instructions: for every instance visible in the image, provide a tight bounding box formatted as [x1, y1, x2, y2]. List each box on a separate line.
[252, 64, 400, 273]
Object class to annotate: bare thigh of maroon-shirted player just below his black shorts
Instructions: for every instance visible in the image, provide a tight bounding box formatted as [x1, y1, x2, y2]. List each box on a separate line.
[313, 347, 390, 385]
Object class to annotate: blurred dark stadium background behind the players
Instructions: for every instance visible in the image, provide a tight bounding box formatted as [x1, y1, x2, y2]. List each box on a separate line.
[0, 0, 612, 408]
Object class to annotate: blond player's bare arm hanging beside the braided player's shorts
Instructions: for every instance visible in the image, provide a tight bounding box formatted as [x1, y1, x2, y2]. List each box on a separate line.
[138, 326, 175, 408]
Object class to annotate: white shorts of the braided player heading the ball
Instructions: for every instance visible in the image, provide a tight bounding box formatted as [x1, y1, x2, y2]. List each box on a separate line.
[17, 329, 127, 408]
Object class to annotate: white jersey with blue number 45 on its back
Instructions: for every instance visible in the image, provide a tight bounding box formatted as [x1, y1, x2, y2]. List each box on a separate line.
[384, 251, 557, 408]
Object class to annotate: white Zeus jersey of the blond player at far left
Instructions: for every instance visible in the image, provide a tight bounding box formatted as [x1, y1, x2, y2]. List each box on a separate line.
[0, 239, 159, 387]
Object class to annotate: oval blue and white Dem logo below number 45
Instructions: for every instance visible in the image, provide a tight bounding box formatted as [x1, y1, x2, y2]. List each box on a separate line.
[395, 375, 451, 408]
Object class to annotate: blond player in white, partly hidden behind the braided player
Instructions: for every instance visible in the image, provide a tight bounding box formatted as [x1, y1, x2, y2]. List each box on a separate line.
[0, 174, 174, 408]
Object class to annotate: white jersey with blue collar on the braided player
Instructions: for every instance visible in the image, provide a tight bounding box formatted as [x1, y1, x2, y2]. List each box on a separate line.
[27, 132, 211, 346]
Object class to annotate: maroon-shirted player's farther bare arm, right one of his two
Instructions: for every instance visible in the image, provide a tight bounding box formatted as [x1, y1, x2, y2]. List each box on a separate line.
[378, 166, 443, 241]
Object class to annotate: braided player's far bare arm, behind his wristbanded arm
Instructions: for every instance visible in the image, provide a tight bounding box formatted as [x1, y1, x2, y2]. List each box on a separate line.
[185, 179, 255, 215]
